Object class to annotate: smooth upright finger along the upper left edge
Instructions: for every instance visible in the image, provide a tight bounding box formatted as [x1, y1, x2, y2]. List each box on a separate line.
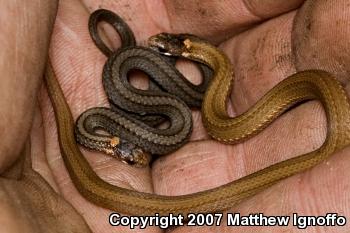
[0, 1, 56, 172]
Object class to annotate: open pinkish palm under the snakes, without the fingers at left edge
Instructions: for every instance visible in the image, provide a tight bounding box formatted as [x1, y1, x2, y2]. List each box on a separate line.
[1, 0, 349, 232]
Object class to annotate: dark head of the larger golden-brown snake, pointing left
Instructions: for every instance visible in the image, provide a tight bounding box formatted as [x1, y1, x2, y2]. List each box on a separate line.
[148, 33, 189, 56]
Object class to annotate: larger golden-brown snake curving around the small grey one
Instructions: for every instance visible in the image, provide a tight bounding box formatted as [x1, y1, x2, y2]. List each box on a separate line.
[45, 31, 350, 215]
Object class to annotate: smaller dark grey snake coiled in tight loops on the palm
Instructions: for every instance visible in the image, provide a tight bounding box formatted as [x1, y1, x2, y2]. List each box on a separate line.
[75, 9, 211, 166]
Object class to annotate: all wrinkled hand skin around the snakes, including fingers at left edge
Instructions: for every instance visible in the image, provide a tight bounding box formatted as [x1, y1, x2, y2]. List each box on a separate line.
[0, 0, 350, 233]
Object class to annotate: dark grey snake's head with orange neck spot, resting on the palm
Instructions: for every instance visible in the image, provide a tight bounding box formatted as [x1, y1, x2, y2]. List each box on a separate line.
[108, 140, 151, 167]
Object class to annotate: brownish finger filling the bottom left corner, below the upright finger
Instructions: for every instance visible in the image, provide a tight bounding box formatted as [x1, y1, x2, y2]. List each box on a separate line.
[0, 141, 91, 232]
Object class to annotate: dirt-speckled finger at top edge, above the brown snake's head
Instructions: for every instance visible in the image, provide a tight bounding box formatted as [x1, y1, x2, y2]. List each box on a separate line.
[163, 0, 303, 43]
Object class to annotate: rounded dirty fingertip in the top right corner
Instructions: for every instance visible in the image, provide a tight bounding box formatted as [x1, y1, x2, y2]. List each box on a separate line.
[292, 0, 350, 86]
